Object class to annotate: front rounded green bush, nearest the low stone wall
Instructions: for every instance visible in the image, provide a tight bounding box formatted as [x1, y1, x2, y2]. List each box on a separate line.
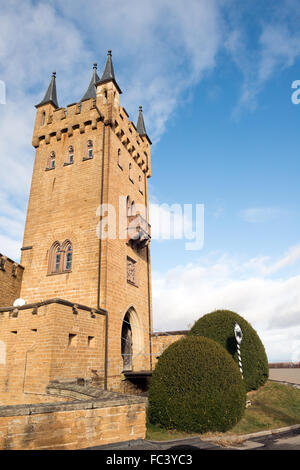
[148, 336, 246, 433]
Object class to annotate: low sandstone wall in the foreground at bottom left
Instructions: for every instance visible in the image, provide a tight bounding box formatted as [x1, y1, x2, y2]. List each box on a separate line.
[0, 396, 146, 450]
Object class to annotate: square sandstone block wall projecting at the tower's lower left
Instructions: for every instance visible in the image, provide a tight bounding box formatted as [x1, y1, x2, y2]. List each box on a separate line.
[0, 299, 105, 405]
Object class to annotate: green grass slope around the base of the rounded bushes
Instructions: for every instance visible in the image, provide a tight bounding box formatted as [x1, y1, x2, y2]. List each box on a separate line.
[147, 382, 300, 441]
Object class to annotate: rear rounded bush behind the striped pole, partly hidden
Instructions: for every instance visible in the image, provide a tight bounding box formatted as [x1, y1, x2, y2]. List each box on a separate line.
[189, 310, 269, 391]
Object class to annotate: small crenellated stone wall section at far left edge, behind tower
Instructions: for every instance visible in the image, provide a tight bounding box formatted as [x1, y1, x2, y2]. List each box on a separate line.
[0, 253, 24, 307]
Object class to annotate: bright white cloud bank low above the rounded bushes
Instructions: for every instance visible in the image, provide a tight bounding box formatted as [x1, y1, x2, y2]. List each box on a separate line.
[153, 247, 300, 360]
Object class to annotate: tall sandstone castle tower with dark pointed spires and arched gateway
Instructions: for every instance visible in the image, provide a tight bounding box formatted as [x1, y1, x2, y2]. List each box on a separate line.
[21, 51, 152, 388]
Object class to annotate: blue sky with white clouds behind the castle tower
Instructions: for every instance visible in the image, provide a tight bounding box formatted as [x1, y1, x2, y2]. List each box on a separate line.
[0, 0, 300, 361]
